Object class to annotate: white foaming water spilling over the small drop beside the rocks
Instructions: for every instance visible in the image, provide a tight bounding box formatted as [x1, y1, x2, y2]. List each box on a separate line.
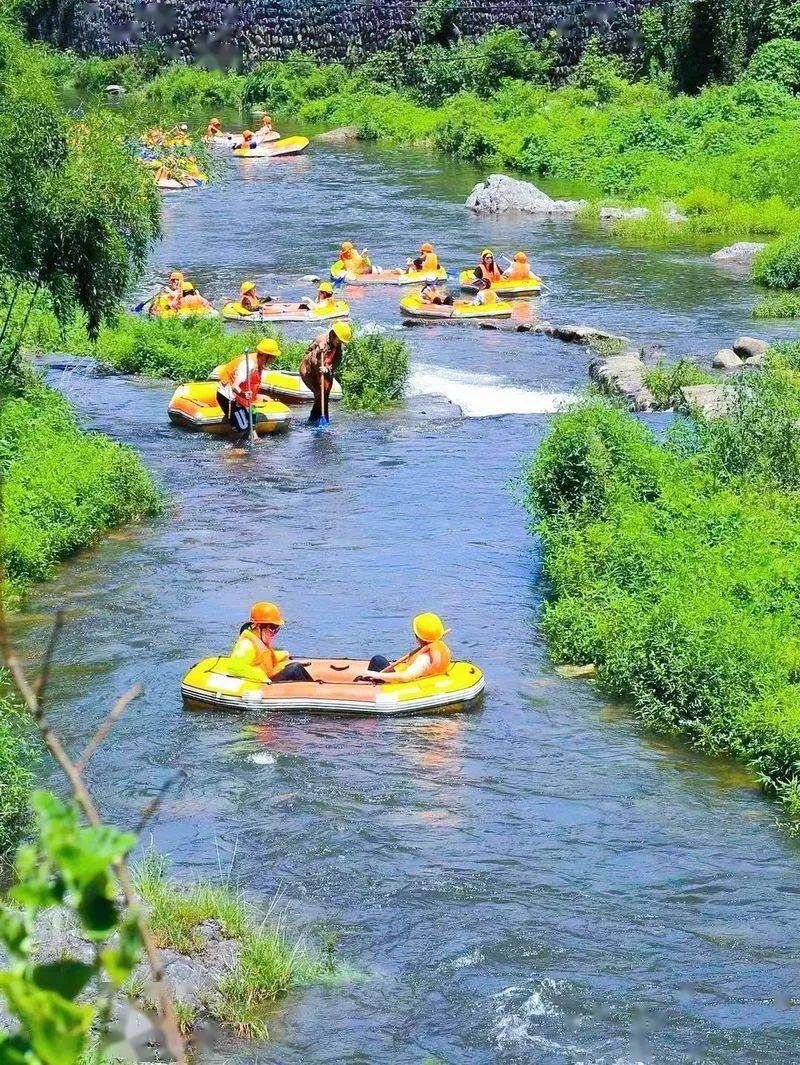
[408, 363, 575, 417]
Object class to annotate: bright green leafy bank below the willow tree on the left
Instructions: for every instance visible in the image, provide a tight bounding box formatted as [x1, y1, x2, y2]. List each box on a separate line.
[0, 375, 161, 600]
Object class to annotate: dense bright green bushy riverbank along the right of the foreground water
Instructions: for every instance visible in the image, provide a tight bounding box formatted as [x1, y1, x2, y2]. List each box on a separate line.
[525, 344, 800, 815]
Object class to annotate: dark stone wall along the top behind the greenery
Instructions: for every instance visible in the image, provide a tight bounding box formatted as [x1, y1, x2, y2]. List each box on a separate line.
[39, 0, 658, 66]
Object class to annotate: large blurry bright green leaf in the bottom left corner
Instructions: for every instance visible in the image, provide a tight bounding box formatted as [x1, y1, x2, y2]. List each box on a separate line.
[0, 972, 94, 1065]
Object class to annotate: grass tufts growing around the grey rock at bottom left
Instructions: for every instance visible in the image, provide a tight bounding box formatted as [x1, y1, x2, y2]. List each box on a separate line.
[133, 851, 349, 1039]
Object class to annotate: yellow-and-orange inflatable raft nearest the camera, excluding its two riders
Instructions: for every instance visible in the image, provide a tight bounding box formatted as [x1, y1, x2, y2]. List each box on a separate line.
[181, 657, 485, 717]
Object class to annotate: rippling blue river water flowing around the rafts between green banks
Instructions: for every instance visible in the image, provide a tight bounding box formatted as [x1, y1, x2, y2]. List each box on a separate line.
[18, 139, 800, 1065]
